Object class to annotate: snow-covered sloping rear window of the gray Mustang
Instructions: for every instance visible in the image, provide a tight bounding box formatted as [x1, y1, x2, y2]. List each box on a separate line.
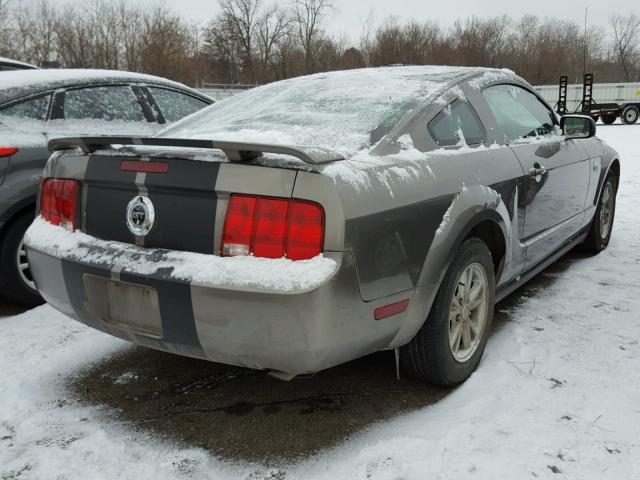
[159, 67, 450, 153]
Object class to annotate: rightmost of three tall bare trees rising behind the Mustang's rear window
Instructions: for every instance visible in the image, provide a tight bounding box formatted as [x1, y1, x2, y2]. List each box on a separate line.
[293, 0, 333, 73]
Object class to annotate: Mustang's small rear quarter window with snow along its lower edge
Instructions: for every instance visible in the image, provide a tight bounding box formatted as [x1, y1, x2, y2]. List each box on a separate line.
[427, 100, 485, 147]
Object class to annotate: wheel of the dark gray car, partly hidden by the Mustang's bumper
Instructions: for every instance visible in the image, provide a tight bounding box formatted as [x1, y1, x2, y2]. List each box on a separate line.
[0, 213, 43, 307]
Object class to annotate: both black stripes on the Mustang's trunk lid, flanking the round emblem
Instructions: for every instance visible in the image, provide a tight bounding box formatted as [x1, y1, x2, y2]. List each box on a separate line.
[85, 155, 220, 253]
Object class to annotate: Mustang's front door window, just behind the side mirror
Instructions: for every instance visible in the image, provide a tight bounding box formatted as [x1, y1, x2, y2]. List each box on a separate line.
[482, 85, 558, 140]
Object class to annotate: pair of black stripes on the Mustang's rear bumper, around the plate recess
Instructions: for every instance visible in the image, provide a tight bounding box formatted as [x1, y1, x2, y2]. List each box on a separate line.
[62, 260, 206, 358]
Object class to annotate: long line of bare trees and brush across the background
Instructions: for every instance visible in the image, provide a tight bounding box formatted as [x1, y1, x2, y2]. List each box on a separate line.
[0, 0, 640, 86]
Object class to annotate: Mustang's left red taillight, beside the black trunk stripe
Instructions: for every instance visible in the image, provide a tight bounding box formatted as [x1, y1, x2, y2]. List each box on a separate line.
[40, 178, 80, 232]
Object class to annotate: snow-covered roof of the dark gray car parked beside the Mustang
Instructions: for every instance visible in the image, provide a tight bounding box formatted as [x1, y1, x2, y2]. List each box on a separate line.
[0, 69, 202, 105]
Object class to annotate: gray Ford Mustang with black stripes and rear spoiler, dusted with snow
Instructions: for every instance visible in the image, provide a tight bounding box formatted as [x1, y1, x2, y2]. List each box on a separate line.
[25, 67, 620, 385]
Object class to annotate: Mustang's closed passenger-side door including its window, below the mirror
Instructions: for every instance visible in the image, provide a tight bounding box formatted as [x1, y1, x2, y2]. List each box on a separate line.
[482, 84, 590, 269]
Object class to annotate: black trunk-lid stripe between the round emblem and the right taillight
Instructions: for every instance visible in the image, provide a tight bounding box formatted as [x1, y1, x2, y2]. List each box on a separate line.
[144, 159, 220, 254]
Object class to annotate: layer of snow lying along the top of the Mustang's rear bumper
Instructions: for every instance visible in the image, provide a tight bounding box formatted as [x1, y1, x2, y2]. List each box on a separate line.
[25, 217, 337, 293]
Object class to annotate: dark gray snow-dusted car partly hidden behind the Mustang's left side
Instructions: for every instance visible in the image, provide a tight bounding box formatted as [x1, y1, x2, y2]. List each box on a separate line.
[0, 70, 212, 305]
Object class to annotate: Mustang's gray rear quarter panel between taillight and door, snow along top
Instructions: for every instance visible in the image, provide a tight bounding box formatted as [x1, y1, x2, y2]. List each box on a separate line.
[316, 142, 523, 301]
